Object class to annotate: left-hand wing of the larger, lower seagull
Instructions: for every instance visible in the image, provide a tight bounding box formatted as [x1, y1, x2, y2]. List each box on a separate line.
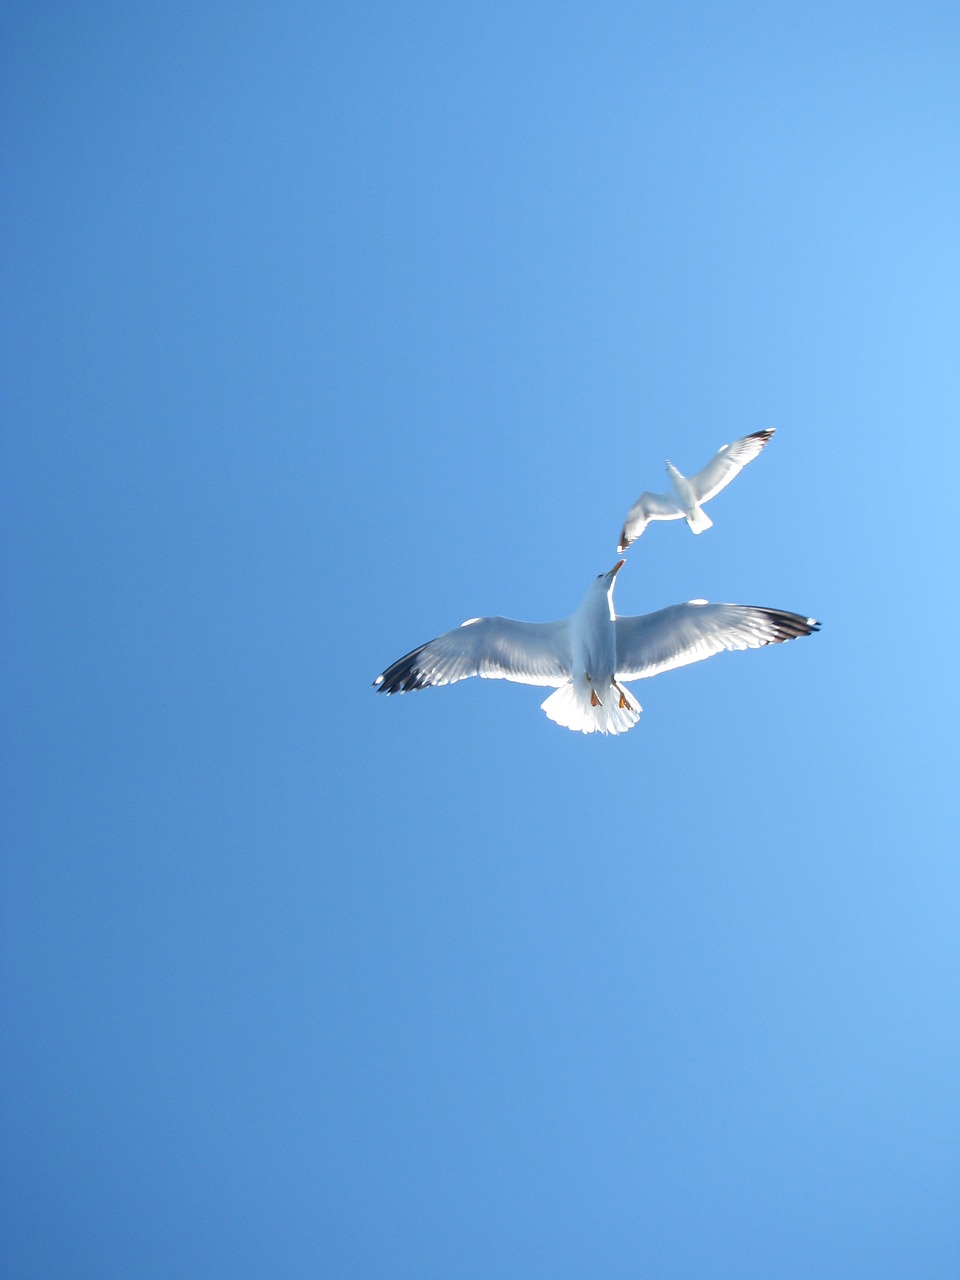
[374, 618, 571, 694]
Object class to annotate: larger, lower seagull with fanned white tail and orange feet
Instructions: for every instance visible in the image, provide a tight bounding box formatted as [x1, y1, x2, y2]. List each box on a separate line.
[374, 559, 820, 733]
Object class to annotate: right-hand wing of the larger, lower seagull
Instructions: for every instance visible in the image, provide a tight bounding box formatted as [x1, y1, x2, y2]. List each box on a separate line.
[617, 600, 820, 680]
